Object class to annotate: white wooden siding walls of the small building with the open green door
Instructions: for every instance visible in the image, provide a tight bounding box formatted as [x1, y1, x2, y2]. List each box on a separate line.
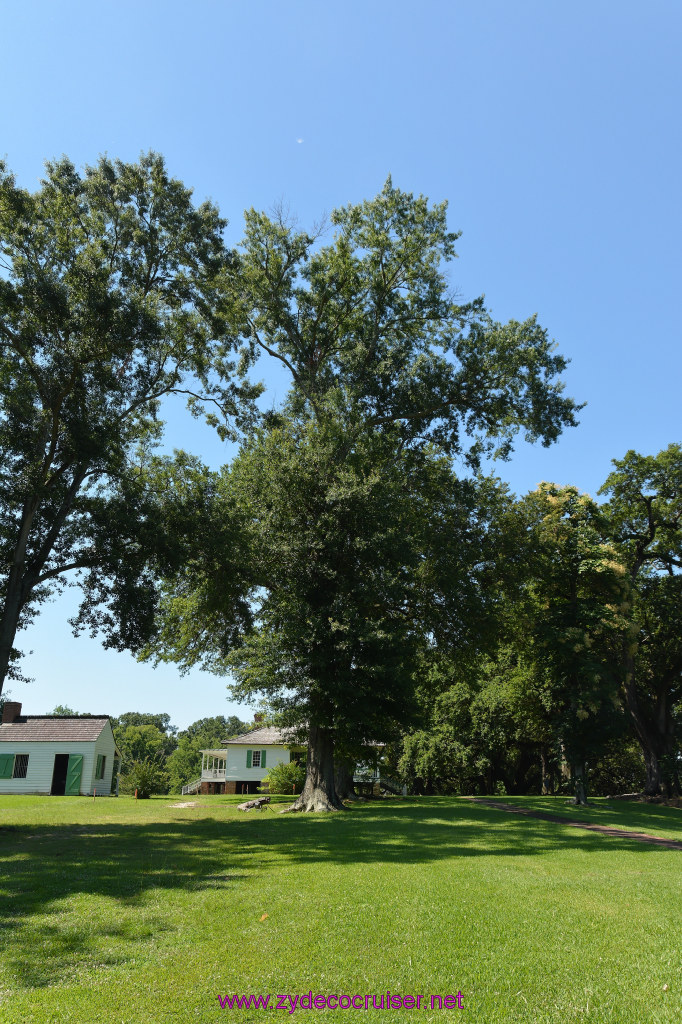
[0, 722, 116, 797]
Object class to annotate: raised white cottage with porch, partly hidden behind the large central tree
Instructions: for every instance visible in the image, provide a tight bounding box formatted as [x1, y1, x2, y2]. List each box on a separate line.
[196, 726, 305, 794]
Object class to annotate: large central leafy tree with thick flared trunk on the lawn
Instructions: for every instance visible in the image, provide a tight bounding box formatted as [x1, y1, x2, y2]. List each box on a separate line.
[140, 179, 578, 809]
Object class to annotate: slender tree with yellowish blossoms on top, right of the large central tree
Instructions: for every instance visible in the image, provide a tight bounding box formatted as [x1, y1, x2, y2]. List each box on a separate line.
[514, 483, 628, 804]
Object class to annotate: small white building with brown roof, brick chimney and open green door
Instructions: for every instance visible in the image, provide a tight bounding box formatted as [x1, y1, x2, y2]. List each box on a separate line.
[0, 701, 118, 797]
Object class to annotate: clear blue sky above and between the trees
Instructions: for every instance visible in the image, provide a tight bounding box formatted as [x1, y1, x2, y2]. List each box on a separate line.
[0, 0, 682, 727]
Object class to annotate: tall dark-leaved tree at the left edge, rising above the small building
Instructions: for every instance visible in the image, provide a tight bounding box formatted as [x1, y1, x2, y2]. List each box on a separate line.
[0, 154, 260, 692]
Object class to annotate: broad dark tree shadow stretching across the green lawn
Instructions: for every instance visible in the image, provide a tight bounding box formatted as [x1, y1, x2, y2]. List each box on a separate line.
[0, 798, 667, 987]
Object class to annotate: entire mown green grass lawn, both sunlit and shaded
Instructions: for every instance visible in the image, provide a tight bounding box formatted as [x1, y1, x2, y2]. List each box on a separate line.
[0, 797, 682, 1024]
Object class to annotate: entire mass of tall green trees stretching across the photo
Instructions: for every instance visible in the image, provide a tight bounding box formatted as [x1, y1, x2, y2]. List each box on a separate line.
[0, 154, 680, 810]
